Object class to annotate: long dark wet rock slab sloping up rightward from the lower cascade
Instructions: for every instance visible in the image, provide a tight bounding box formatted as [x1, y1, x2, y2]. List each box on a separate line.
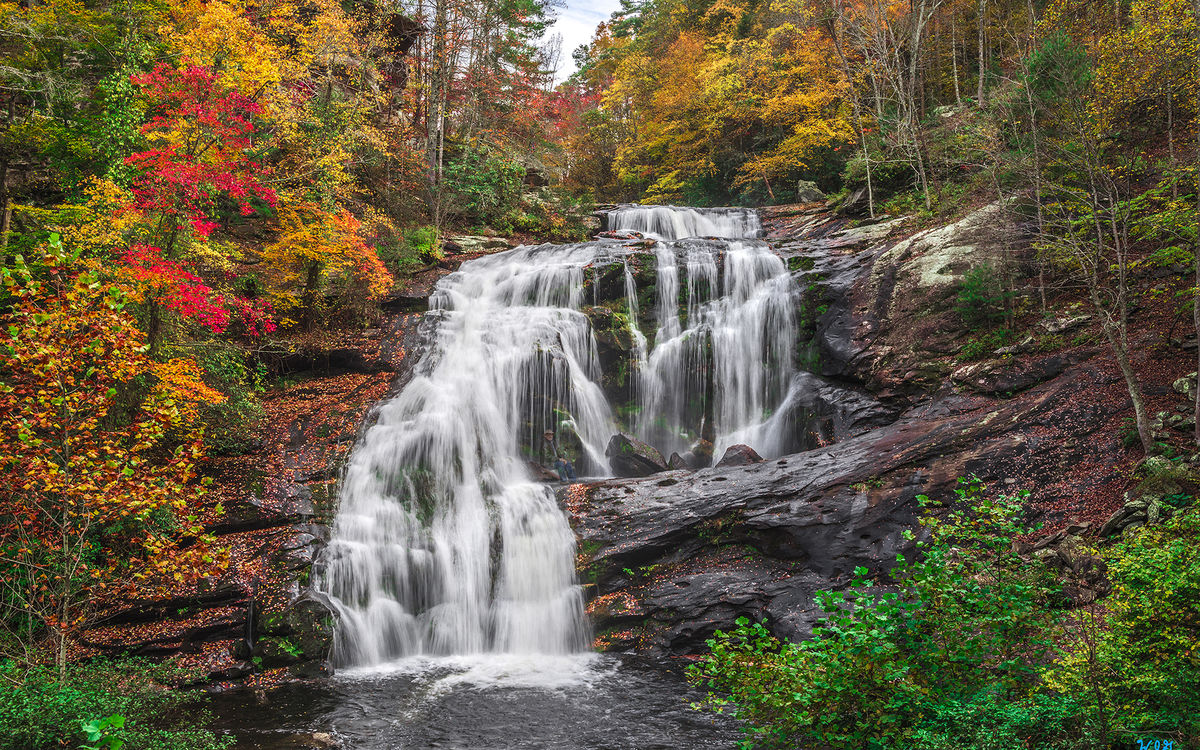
[562, 348, 1117, 654]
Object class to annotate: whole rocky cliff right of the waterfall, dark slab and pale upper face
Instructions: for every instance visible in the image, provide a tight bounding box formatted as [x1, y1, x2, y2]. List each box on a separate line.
[560, 205, 1187, 654]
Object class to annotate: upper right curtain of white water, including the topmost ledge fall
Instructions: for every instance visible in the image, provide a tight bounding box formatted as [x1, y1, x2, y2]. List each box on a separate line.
[608, 206, 798, 456]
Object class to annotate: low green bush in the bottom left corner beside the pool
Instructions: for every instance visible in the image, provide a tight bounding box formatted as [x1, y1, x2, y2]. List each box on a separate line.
[0, 660, 233, 750]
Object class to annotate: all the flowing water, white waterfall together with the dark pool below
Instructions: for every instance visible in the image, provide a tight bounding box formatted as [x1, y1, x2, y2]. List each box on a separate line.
[217, 206, 798, 749]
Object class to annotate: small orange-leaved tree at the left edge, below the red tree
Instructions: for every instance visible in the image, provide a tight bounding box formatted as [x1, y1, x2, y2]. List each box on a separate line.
[0, 238, 222, 673]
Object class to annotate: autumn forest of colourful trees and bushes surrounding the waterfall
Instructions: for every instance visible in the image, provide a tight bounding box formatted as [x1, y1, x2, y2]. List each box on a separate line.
[0, 0, 1200, 750]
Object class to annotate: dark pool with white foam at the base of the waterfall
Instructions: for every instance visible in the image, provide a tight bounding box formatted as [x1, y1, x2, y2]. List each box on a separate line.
[211, 654, 740, 750]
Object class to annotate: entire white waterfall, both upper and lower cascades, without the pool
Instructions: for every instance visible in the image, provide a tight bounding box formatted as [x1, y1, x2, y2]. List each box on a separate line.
[322, 208, 796, 666]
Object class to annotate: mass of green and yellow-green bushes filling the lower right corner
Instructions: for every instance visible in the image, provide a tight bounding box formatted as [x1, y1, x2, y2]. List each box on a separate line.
[690, 481, 1200, 750]
